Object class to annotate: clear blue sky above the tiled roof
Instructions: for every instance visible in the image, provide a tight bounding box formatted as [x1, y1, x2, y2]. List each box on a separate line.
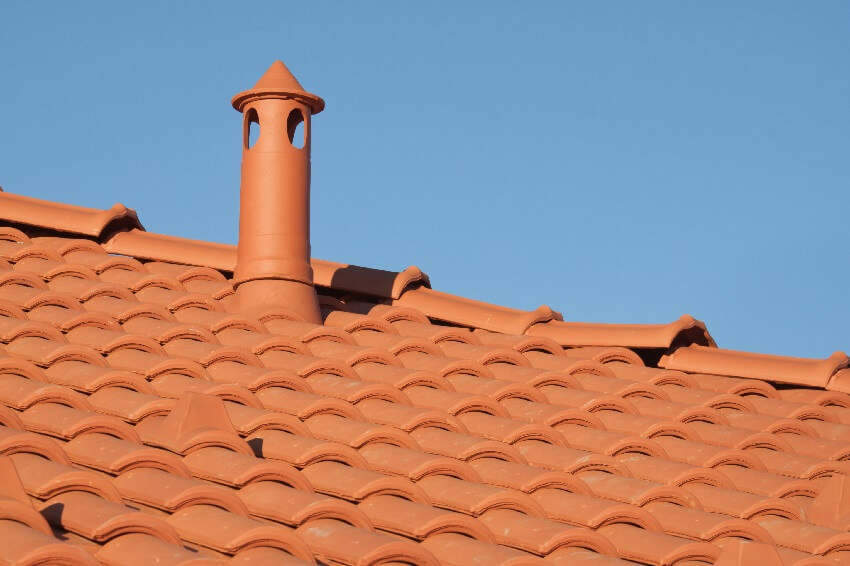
[0, 1, 850, 357]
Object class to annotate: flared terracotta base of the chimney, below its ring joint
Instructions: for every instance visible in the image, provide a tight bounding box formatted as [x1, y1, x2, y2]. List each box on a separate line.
[236, 279, 322, 324]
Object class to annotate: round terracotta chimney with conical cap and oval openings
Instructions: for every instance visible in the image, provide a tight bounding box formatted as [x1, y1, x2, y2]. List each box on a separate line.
[231, 61, 325, 324]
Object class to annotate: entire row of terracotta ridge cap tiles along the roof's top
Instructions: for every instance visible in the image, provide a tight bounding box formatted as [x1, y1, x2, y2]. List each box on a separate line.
[28, 188, 850, 368]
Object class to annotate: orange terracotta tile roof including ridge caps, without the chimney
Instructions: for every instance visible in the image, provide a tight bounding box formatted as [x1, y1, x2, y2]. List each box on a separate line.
[0, 192, 850, 566]
